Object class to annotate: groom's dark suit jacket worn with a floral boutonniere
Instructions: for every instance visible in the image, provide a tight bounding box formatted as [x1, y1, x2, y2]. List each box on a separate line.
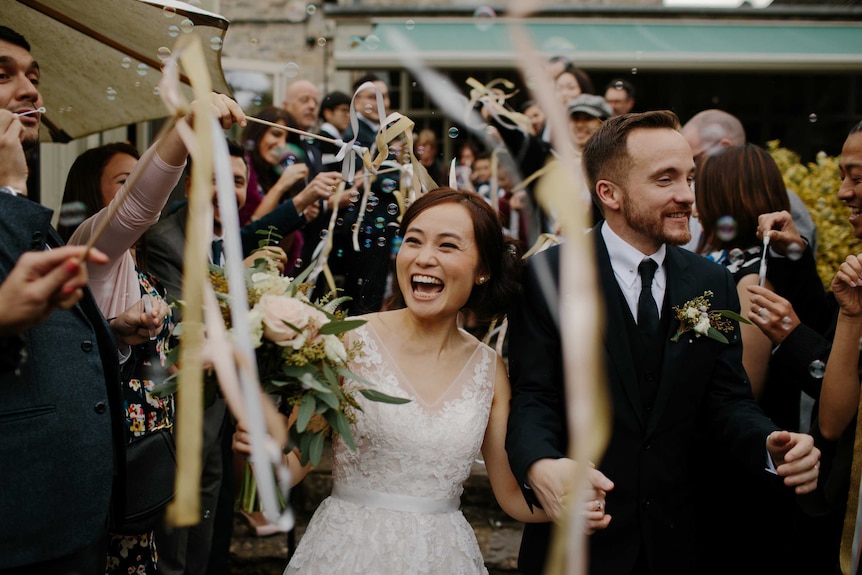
[506, 226, 777, 575]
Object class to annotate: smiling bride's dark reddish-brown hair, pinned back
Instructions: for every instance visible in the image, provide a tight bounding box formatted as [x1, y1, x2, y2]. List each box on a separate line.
[384, 187, 523, 322]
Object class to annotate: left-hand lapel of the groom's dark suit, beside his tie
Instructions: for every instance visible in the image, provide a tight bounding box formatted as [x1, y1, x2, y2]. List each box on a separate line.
[592, 230, 646, 427]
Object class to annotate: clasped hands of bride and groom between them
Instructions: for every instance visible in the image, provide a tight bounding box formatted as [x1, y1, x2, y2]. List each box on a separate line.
[527, 458, 614, 535]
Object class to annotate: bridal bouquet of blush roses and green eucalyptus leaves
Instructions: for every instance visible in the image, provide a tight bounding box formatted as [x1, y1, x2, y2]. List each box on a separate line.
[210, 244, 407, 465]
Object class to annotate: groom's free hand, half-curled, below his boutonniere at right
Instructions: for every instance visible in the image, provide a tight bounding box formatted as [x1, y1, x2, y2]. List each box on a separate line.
[766, 431, 820, 495]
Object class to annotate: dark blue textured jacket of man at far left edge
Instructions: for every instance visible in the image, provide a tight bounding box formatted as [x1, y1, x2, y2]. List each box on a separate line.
[0, 194, 125, 569]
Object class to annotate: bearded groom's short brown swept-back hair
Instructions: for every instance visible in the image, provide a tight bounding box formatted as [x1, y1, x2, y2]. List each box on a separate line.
[581, 110, 680, 203]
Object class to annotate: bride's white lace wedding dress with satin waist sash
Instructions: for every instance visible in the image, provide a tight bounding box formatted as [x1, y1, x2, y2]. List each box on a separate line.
[285, 324, 497, 575]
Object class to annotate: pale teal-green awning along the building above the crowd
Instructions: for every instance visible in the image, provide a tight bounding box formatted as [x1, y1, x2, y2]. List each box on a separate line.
[335, 17, 862, 71]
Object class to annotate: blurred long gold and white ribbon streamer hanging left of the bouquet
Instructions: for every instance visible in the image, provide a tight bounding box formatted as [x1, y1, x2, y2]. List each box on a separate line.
[162, 36, 293, 530]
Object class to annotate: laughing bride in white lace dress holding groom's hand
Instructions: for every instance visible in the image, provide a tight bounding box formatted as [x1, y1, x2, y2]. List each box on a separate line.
[234, 188, 610, 575]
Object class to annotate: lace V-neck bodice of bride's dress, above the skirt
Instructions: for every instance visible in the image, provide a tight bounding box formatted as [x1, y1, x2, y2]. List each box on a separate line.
[333, 324, 496, 499]
